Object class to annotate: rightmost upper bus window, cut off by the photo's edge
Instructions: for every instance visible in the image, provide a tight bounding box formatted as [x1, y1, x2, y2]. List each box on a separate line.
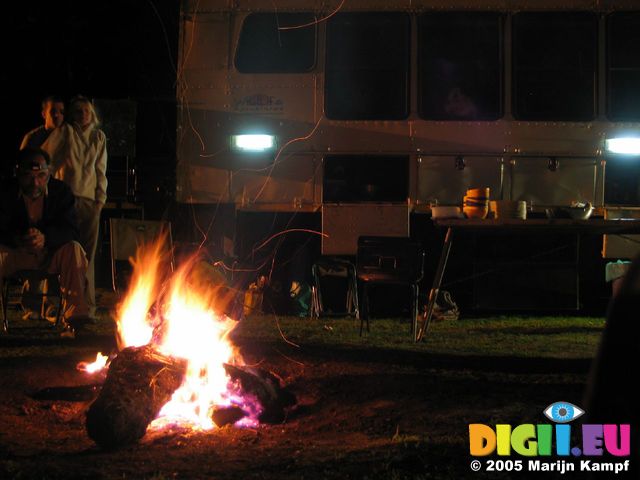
[607, 12, 640, 121]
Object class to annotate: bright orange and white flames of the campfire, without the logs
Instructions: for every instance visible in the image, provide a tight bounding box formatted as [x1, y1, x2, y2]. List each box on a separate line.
[109, 238, 251, 429]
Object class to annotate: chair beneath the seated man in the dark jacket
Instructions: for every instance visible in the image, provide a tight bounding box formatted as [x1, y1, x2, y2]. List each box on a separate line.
[2, 270, 64, 333]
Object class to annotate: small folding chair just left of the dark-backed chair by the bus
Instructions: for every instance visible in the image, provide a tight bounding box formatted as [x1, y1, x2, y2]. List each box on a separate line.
[311, 257, 360, 318]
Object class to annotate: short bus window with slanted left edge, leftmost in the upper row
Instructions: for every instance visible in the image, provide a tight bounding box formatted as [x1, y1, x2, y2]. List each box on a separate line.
[235, 13, 316, 73]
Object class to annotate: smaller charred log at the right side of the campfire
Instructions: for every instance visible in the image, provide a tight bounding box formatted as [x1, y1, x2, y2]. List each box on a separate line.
[224, 363, 296, 423]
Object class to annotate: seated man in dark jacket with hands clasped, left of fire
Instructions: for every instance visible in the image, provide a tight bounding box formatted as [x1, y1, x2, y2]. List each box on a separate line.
[0, 147, 90, 327]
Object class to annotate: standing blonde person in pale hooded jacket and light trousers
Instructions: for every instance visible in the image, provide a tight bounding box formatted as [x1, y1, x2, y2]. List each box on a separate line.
[42, 96, 107, 316]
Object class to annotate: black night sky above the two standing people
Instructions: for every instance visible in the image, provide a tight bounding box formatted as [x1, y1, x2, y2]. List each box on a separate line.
[0, 0, 179, 206]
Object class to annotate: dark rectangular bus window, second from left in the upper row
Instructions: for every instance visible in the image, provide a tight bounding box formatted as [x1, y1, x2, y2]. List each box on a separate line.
[325, 12, 410, 120]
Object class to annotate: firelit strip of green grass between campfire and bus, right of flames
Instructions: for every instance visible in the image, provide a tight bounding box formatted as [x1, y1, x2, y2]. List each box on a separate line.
[234, 316, 604, 358]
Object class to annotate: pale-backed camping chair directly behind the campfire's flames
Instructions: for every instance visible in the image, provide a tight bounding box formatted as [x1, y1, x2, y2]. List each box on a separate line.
[109, 218, 173, 293]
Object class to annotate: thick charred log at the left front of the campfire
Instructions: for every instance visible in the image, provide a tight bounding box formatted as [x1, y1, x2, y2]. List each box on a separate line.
[86, 345, 187, 449]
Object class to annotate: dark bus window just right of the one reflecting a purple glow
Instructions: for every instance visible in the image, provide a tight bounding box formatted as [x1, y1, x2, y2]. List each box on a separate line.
[513, 12, 598, 121]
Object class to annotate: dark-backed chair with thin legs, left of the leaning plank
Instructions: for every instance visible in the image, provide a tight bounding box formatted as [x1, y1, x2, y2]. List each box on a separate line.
[356, 237, 424, 336]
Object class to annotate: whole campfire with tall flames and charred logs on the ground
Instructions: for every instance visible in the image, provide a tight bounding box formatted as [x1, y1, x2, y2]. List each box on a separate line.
[79, 242, 295, 448]
